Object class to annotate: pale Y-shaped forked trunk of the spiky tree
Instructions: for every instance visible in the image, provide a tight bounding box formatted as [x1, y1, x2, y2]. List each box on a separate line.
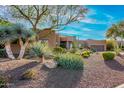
[18, 38, 29, 59]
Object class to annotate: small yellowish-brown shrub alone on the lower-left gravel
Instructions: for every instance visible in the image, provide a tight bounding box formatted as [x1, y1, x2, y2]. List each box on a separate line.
[21, 70, 37, 80]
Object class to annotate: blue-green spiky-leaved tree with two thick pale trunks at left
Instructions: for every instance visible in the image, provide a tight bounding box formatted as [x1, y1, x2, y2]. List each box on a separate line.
[0, 24, 35, 59]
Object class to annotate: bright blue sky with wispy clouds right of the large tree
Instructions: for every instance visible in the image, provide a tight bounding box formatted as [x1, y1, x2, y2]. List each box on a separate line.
[60, 5, 124, 40]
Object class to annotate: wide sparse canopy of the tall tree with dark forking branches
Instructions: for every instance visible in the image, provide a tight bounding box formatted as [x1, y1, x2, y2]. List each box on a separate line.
[10, 5, 87, 31]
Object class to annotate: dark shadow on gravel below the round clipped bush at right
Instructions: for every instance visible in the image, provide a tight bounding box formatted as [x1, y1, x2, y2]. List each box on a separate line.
[104, 60, 124, 71]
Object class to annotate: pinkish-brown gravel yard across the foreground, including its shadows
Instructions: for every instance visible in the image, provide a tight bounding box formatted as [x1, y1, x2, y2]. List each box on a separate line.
[0, 53, 124, 88]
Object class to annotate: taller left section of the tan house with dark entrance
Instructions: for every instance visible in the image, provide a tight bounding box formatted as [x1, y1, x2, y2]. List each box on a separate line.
[38, 29, 76, 49]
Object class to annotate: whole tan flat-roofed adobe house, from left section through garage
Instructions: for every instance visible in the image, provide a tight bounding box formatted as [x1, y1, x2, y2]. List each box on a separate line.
[38, 29, 106, 51]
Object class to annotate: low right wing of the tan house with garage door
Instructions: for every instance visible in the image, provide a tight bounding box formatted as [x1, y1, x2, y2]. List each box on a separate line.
[79, 39, 106, 51]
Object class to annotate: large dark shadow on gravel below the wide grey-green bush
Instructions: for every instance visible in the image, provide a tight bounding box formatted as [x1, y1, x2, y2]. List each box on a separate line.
[41, 66, 83, 88]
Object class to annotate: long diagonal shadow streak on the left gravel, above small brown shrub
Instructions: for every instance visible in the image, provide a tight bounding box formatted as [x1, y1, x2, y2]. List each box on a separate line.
[6, 61, 40, 79]
